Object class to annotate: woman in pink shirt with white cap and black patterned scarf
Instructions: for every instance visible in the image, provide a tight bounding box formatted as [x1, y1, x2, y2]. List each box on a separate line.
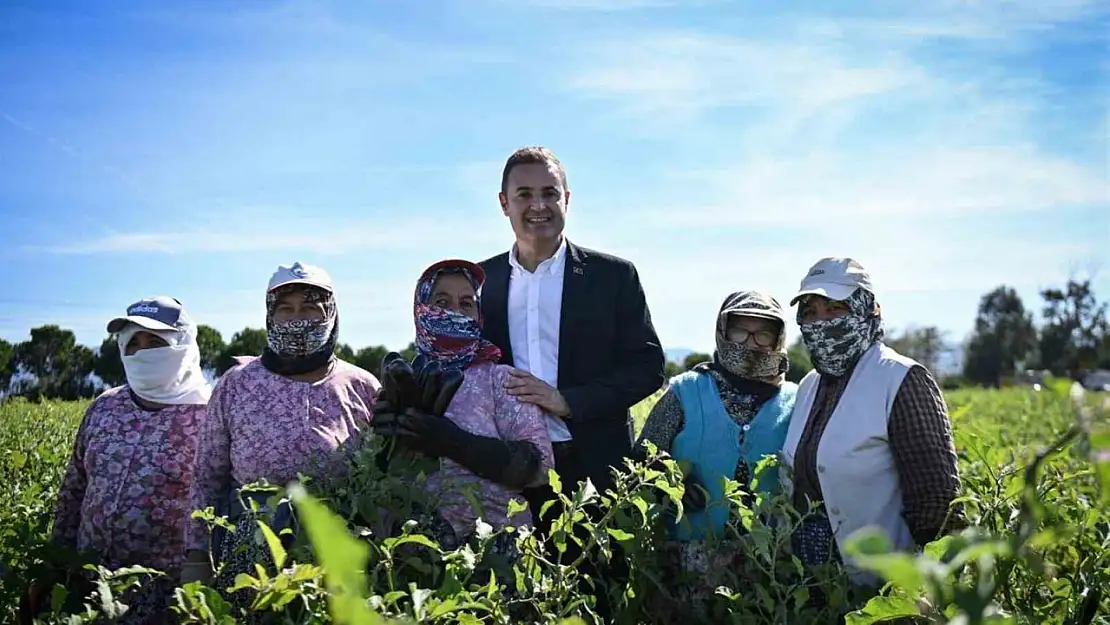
[185, 263, 381, 603]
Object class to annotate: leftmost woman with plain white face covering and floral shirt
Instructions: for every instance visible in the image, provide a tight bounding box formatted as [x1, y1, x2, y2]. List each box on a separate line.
[40, 296, 211, 623]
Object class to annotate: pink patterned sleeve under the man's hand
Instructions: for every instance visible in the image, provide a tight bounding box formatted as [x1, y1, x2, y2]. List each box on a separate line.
[493, 367, 555, 486]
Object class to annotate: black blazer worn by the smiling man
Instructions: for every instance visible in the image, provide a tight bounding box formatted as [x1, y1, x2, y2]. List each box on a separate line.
[481, 241, 666, 488]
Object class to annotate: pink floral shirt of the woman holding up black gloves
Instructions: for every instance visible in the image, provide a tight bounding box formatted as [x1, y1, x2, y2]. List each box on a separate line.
[427, 364, 555, 536]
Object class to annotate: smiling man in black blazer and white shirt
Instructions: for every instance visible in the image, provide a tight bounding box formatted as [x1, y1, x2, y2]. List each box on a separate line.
[482, 148, 665, 534]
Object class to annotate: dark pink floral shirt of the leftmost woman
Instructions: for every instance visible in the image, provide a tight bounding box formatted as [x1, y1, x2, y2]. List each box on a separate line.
[53, 386, 205, 576]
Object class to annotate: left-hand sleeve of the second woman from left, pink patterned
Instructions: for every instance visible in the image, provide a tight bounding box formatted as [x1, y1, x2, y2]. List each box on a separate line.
[185, 375, 231, 551]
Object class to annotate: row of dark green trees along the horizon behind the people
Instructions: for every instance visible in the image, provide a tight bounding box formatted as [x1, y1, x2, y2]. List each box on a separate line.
[0, 280, 1110, 401]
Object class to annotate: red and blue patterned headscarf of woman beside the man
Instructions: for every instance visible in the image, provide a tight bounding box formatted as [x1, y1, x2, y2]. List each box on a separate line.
[413, 263, 501, 372]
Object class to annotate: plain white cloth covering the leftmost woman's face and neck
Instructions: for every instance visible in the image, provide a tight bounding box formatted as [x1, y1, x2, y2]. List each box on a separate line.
[118, 324, 212, 404]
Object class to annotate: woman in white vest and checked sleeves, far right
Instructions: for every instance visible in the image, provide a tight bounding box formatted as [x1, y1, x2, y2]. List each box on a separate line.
[783, 258, 960, 599]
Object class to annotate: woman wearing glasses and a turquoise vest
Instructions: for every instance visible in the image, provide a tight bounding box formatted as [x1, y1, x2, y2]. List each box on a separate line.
[635, 291, 797, 618]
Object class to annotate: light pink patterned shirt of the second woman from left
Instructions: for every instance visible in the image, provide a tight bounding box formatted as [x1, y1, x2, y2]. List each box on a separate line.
[186, 359, 381, 551]
